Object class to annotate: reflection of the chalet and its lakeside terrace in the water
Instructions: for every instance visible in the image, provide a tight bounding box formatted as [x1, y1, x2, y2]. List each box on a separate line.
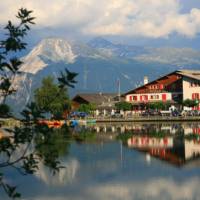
[83, 123, 200, 167]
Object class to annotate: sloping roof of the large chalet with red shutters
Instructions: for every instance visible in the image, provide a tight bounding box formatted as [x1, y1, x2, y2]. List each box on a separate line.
[123, 70, 200, 96]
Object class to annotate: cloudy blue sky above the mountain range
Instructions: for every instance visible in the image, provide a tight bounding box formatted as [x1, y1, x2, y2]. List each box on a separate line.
[0, 0, 200, 48]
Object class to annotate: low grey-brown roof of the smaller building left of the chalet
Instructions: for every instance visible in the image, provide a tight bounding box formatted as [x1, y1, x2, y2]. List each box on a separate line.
[72, 93, 117, 105]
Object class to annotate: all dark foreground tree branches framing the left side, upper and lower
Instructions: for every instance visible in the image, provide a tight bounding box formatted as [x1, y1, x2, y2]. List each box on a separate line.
[0, 8, 77, 199]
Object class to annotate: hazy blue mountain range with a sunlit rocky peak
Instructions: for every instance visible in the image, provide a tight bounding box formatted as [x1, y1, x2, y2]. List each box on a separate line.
[8, 37, 200, 111]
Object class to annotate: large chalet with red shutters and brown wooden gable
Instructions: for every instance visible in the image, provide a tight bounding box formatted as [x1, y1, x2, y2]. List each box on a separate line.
[124, 70, 200, 110]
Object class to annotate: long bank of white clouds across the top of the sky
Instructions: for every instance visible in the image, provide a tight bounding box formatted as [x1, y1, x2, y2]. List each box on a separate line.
[0, 0, 200, 38]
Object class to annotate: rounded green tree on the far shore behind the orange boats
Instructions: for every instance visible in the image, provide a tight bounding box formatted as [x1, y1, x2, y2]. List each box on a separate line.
[34, 76, 70, 118]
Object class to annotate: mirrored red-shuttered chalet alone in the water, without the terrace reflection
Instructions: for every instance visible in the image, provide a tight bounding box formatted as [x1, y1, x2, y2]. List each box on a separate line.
[128, 137, 200, 166]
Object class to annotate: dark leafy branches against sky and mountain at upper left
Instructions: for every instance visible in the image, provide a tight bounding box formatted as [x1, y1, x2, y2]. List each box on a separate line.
[0, 8, 35, 104]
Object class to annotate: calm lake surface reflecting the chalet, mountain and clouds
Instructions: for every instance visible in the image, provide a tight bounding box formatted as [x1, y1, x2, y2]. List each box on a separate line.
[0, 123, 200, 200]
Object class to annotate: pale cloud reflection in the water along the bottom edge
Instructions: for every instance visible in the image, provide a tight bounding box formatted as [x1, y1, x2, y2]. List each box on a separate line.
[86, 178, 199, 200]
